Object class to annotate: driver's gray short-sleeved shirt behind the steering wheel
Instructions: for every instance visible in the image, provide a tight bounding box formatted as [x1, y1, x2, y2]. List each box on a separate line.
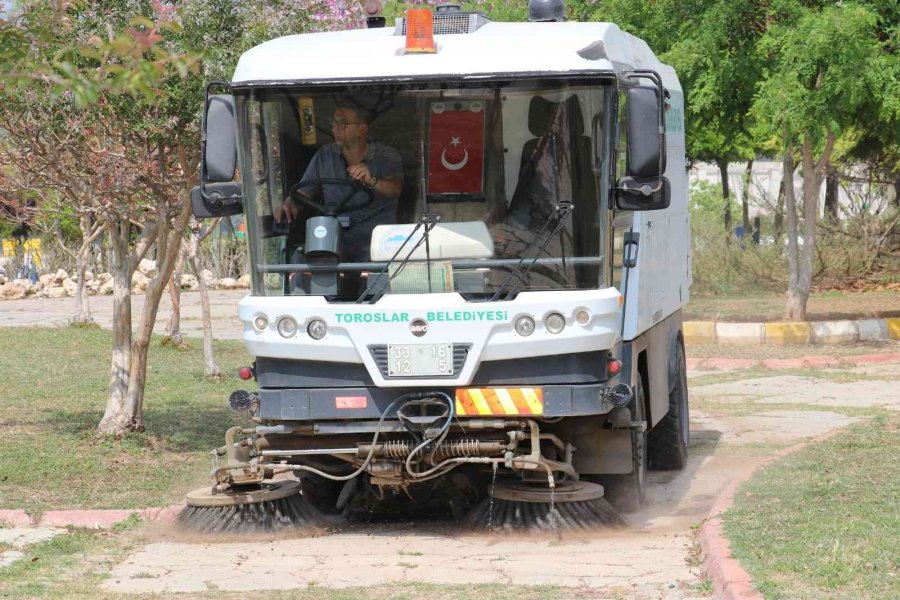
[300, 142, 403, 261]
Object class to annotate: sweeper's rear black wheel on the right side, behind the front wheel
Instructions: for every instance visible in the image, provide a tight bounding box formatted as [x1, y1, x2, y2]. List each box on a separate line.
[648, 341, 690, 471]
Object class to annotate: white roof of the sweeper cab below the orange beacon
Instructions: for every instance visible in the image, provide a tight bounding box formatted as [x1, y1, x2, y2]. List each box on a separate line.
[232, 21, 677, 87]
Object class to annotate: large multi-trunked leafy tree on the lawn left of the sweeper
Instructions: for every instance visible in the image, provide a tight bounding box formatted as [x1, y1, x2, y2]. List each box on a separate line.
[0, 0, 362, 435]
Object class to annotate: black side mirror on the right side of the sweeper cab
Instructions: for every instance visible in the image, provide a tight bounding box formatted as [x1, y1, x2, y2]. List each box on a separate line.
[616, 79, 671, 210]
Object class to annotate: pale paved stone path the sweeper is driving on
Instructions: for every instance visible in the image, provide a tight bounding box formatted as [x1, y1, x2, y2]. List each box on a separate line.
[96, 363, 900, 600]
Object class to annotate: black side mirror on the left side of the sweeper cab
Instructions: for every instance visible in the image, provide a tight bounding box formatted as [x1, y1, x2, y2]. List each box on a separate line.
[191, 81, 243, 218]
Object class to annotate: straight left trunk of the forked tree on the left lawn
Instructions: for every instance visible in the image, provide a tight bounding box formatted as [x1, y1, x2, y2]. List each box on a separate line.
[97, 221, 134, 435]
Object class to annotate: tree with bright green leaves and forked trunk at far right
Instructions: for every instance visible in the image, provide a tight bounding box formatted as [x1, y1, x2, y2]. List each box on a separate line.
[752, 1, 900, 321]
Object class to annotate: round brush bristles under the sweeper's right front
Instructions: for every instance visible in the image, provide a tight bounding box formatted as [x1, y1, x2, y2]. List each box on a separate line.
[466, 498, 628, 532]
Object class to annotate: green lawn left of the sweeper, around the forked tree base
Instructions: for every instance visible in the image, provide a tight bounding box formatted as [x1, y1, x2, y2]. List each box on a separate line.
[0, 327, 249, 514]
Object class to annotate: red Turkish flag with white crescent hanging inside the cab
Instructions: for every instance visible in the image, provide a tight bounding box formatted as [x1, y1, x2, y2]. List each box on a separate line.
[428, 100, 485, 195]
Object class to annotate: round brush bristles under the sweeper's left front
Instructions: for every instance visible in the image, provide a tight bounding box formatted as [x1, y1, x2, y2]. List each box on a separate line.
[178, 494, 323, 534]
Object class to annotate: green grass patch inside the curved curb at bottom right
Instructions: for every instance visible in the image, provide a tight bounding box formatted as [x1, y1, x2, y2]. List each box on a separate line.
[724, 415, 900, 600]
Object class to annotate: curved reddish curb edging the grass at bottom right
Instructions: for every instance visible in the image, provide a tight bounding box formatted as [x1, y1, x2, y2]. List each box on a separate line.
[700, 429, 842, 600]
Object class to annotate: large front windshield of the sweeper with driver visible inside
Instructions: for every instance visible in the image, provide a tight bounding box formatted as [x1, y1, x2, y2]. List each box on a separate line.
[236, 79, 615, 302]
